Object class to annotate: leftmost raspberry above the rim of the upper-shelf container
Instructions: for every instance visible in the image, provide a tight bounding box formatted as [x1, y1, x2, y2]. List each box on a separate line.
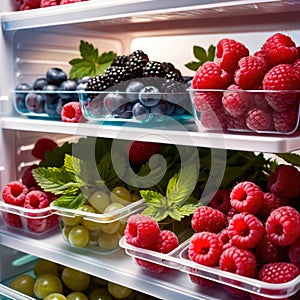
[192, 61, 231, 89]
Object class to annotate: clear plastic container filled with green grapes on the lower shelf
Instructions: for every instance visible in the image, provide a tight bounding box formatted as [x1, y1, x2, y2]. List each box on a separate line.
[51, 199, 145, 254]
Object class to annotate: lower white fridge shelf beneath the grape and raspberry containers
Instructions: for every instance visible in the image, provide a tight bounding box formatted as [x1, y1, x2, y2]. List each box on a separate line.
[0, 228, 230, 300]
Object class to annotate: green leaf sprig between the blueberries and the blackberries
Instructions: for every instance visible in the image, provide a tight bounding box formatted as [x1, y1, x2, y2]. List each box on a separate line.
[69, 40, 117, 80]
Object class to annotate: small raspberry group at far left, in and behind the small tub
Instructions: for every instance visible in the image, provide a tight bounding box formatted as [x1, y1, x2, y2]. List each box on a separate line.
[2, 138, 58, 233]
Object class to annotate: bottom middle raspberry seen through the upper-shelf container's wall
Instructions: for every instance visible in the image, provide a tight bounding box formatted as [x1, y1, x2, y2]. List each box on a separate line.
[246, 108, 274, 131]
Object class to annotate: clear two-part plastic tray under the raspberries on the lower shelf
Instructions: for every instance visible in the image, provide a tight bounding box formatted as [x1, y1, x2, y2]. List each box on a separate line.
[120, 237, 300, 299]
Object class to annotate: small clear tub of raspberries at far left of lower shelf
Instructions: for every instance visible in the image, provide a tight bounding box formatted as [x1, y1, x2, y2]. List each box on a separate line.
[0, 201, 59, 237]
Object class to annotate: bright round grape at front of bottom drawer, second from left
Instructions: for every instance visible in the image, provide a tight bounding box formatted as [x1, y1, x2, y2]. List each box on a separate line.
[33, 274, 63, 299]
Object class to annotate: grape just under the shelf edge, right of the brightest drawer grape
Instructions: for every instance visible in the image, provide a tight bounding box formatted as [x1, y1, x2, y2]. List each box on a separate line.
[61, 267, 91, 292]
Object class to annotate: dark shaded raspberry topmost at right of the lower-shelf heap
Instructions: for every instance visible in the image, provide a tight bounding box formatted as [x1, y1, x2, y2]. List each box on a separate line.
[268, 164, 300, 199]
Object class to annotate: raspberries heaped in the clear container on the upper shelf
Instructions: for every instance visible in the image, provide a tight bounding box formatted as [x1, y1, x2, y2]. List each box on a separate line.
[192, 33, 300, 133]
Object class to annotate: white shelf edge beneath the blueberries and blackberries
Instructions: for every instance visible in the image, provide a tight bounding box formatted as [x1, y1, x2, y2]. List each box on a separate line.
[0, 117, 300, 153]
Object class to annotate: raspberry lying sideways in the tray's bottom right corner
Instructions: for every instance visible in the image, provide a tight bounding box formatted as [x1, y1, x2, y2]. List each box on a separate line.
[258, 262, 300, 283]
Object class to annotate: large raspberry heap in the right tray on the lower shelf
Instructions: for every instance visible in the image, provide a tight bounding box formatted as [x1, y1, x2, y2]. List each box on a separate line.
[188, 164, 300, 300]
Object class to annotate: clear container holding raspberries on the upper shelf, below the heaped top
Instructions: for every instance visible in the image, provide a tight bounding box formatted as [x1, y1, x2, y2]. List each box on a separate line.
[189, 88, 300, 135]
